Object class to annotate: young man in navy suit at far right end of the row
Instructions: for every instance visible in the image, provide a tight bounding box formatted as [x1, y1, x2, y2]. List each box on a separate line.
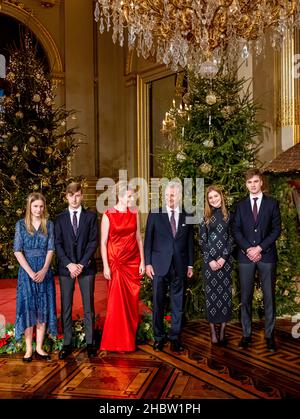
[233, 169, 281, 351]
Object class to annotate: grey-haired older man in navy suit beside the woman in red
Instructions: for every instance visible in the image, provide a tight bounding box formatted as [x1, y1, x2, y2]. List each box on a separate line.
[144, 182, 193, 352]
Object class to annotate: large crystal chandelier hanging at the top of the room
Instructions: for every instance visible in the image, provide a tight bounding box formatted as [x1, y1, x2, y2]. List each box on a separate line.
[94, 0, 300, 77]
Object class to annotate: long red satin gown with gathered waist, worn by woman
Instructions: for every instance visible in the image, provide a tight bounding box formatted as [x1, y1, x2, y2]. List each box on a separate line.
[100, 208, 141, 351]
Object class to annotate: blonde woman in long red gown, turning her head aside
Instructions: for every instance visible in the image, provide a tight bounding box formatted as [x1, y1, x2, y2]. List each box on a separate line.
[100, 182, 145, 352]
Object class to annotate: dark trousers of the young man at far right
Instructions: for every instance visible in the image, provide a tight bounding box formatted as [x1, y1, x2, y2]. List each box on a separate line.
[239, 262, 276, 338]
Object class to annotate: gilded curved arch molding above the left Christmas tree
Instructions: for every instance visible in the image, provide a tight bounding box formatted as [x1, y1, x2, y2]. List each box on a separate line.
[0, 1, 64, 83]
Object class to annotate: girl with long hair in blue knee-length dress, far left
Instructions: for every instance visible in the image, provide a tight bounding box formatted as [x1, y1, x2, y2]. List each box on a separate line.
[14, 193, 57, 362]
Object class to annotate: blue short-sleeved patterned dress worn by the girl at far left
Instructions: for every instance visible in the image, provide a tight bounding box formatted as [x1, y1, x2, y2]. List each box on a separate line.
[14, 220, 57, 340]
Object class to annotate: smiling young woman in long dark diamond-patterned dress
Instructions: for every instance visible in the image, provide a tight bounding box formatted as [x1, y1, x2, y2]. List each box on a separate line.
[200, 186, 233, 345]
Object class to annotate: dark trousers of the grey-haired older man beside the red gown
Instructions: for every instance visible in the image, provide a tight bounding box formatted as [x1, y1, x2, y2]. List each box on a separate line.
[152, 264, 186, 341]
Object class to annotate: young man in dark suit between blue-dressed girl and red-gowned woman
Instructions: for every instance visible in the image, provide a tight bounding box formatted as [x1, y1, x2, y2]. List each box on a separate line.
[55, 182, 99, 359]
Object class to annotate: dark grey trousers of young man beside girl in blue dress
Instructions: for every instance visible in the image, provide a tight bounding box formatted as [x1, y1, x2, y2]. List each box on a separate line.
[59, 275, 95, 345]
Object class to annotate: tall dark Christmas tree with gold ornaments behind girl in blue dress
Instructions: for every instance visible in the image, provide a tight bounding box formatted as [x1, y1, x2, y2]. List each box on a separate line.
[0, 35, 78, 278]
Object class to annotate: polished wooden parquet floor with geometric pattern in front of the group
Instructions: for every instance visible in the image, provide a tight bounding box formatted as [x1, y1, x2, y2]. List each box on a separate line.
[0, 320, 300, 400]
